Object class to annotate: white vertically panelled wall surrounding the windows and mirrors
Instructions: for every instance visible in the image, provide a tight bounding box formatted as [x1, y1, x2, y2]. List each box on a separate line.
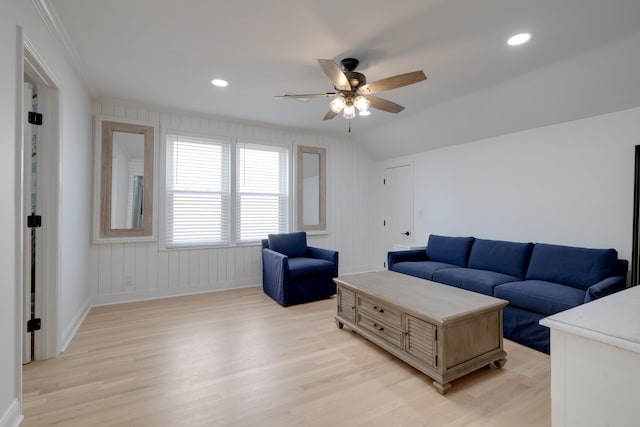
[90, 100, 372, 304]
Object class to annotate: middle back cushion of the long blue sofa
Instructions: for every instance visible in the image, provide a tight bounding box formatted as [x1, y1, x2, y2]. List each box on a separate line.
[469, 239, 533, 279]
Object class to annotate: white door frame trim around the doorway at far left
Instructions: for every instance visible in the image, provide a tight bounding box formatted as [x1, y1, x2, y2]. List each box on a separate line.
[16, 28, 61, 360]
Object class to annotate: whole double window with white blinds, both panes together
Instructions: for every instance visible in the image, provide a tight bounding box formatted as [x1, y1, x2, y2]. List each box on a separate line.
[166, 134, 289, 248]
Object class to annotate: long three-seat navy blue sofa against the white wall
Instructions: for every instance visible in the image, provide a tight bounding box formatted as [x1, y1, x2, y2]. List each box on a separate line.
[387, 234, 629, 353]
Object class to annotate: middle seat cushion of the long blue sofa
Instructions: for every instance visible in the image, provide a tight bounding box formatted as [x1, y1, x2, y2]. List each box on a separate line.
[433, 268, 520, 296]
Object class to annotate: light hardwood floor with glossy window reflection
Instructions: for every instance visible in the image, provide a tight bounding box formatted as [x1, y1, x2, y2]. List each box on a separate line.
[23, 288, 551, 427]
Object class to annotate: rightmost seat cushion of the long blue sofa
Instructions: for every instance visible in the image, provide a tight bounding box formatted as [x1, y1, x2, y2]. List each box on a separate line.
[493, 280, 585, 316]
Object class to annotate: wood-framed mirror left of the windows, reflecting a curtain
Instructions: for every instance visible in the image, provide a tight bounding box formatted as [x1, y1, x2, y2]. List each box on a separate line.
[94, 116, 158, 243]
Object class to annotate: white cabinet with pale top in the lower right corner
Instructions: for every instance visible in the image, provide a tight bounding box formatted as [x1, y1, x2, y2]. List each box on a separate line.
[540, 286, 640, 427]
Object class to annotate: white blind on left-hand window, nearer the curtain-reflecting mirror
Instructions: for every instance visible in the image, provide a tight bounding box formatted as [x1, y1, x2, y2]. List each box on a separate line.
[166, 135, 231, 248]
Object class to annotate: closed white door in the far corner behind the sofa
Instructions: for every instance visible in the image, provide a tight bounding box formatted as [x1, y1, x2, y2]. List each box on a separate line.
[383, 165, 413, 266]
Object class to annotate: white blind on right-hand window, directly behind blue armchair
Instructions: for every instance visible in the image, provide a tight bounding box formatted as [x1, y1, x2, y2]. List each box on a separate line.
[236, 143, 289, 243]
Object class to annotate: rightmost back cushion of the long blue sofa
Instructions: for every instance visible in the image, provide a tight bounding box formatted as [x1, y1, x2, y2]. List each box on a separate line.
[526, 243, 618, 290]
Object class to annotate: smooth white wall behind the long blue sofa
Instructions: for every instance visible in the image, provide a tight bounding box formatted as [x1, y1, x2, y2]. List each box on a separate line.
[373, 108, 640, 268]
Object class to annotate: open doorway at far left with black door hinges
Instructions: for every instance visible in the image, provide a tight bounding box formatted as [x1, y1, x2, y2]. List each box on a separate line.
[20, 36, 60, 363]
